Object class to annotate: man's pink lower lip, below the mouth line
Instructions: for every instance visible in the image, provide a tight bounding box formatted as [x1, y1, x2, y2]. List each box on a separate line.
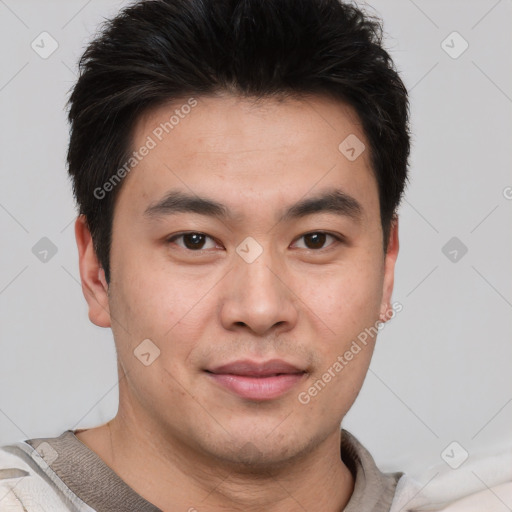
[208, 373, 305, 400]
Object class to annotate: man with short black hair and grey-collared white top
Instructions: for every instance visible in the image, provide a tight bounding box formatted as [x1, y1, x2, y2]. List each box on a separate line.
[0, 0, 464, 512]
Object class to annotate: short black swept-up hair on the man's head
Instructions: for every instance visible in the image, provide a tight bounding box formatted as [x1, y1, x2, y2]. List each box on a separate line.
[67, 0, 410, 282]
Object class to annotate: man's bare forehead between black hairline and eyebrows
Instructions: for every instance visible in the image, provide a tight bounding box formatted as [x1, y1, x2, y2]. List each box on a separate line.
[116, 95, 378, 224]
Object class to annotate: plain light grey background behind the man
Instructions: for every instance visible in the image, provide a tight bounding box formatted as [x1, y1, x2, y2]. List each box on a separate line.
[0, 0, 512, 475]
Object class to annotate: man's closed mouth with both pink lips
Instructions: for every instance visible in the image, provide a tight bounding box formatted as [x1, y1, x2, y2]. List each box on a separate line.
[205, 359, 307, 401]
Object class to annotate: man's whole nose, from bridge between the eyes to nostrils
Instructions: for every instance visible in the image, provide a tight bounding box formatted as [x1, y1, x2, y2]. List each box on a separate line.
[222, 239, 297, 334]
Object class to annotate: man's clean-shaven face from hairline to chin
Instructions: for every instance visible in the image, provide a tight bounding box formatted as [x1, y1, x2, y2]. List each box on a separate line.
[85, 95, 397, 464]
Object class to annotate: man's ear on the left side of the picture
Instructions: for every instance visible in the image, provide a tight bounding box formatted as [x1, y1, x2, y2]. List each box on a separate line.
[75, 215, 111, 327]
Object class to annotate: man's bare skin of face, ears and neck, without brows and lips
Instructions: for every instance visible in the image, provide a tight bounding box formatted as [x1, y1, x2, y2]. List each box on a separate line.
[75, 94, 398, 512]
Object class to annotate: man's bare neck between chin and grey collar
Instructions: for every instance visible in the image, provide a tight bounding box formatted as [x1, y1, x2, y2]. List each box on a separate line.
[77, 409, 354, 512]
